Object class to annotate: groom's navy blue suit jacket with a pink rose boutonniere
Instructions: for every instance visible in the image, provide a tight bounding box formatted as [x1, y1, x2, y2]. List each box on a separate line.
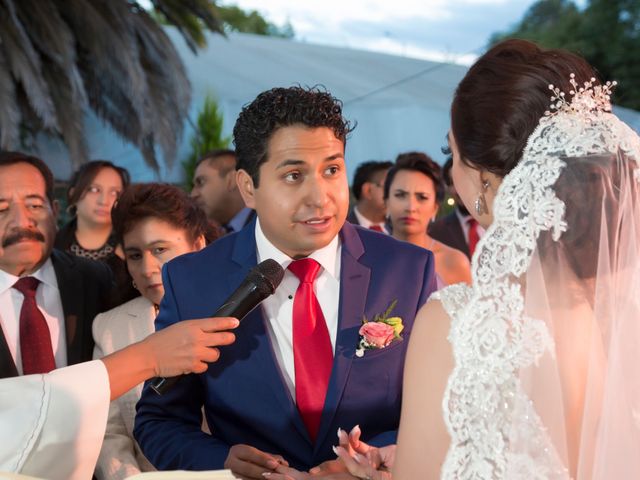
[134, 222, 435, 470]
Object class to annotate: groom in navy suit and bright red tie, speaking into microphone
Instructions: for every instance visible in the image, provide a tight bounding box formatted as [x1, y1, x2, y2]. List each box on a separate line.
[134, 87, 435, 479]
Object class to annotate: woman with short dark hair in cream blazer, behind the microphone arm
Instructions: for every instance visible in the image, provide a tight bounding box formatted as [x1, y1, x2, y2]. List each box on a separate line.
[93, 183, 218, 480]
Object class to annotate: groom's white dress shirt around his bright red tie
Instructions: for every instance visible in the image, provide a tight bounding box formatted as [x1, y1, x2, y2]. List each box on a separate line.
[255, 221, 342, 401]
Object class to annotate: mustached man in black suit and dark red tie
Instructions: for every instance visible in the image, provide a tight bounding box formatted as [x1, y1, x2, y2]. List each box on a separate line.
[0, 152, 112, 378]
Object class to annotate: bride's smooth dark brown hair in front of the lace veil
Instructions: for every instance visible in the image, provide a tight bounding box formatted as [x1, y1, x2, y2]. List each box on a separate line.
[451, 40, 596, 177]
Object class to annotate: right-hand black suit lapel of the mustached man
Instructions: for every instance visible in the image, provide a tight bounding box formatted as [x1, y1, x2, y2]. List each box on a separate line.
[51, 250, 85, 365]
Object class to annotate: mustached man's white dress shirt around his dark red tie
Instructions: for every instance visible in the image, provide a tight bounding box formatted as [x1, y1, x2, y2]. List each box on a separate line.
[0, 258, 67, 375]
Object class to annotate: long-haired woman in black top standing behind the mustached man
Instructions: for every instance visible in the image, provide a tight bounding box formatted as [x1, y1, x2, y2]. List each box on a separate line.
[55, 160, 138, 306]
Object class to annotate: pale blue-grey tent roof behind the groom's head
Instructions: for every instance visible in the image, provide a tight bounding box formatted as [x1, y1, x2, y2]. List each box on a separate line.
[36, 29, 640, 182]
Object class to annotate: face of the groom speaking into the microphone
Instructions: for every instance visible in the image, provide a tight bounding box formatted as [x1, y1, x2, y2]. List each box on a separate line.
[238, 125, 349, 258]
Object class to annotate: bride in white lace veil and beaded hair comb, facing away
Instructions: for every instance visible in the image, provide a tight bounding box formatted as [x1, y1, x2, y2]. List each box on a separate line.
[270, 40, 640, 480]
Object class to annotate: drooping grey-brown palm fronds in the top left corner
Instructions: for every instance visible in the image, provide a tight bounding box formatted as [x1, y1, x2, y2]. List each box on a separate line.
[0, 0, 222, 171]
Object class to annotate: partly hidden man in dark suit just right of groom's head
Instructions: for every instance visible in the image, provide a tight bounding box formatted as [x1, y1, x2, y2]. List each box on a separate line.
[347, 161, 393, 233]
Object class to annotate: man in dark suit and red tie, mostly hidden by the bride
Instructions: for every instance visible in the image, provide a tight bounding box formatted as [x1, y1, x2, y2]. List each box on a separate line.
[429, 158, 484, 260]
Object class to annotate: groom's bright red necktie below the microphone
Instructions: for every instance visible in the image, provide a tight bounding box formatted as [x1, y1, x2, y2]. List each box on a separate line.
[289, 258, 333, 441]
